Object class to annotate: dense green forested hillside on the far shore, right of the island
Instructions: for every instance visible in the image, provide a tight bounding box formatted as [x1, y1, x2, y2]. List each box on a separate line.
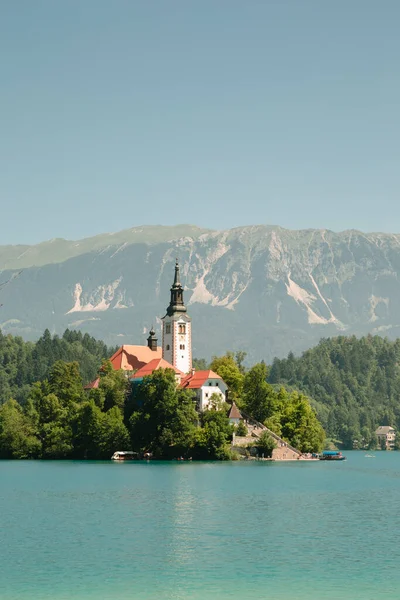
[268, 335, 400, 448]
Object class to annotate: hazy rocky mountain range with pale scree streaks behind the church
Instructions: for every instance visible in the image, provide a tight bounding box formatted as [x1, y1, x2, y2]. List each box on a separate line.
[0, 225, 400, 361]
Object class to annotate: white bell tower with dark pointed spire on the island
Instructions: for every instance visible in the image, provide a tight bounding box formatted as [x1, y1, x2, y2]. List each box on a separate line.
[162, 259, 192, 373]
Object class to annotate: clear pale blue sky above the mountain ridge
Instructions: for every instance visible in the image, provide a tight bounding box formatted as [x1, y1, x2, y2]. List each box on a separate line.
[0, 0, 400, 244]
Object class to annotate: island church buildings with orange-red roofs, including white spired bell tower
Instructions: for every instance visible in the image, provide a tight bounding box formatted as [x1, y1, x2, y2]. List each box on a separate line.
[86, 260, 228, 411]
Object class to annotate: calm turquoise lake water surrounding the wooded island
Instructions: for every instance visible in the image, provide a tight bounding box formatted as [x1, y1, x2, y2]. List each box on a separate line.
[0, 452, 400, 600]
